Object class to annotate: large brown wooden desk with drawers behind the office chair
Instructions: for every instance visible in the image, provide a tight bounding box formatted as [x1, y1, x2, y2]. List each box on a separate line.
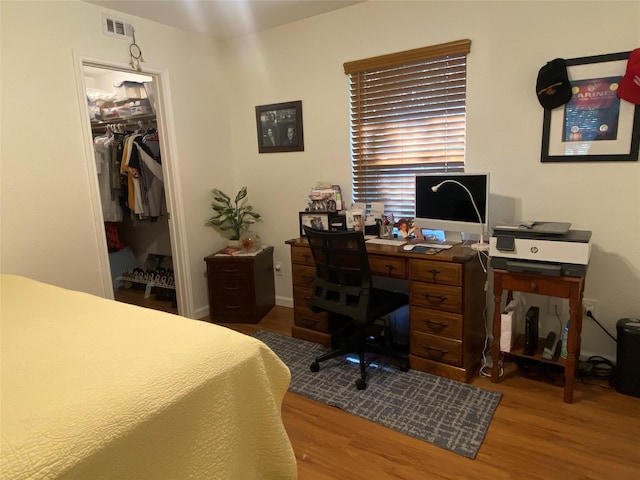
[286, 238, 486, 382]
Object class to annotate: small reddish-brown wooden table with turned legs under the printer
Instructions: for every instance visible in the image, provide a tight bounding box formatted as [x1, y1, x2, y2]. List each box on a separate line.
[491, 270, 584, 403]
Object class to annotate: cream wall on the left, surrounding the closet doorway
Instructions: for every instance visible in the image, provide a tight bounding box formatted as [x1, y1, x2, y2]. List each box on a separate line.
[0, 1, 230, 314]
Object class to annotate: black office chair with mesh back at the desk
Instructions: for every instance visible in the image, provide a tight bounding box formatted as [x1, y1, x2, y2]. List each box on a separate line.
[304, 226, 409, 390]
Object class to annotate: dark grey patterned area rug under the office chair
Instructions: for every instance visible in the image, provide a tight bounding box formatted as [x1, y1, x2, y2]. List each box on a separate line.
[255, 330, 502, 459]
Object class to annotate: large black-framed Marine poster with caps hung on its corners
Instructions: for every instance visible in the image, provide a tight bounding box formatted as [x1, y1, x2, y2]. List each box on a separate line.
[541, 52, 640, 162]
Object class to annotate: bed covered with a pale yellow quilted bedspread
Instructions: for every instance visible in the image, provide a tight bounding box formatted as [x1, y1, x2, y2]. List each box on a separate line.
[0, 275, 297, 480]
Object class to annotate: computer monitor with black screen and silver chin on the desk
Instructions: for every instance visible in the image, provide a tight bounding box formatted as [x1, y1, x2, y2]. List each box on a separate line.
[415, 173, 489, 243]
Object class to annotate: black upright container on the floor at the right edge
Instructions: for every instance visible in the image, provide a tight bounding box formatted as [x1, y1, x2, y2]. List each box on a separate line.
[615, 318, 640, 397]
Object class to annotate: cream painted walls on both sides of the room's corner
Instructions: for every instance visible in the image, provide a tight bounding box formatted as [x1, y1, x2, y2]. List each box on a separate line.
[0, 1, 640, 356]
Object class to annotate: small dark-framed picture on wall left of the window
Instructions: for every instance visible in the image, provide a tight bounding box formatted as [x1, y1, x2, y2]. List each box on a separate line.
[256, 101, 304, 153]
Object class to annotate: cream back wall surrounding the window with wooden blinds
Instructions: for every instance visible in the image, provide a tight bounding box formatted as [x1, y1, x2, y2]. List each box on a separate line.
[227, 1, 640, 357]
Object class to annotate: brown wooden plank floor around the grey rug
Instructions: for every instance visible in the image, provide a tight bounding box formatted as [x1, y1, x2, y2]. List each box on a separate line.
[218, 306, 640, 480]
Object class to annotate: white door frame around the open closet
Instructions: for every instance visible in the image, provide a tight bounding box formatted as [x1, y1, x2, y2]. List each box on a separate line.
[73, 51, 195, 318]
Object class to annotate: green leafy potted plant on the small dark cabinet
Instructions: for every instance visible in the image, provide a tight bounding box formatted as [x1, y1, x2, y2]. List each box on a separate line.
[207, 187, 262, 245]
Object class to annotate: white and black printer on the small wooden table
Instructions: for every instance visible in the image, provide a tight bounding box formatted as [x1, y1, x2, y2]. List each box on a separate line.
[489, 222, 591, 277]
